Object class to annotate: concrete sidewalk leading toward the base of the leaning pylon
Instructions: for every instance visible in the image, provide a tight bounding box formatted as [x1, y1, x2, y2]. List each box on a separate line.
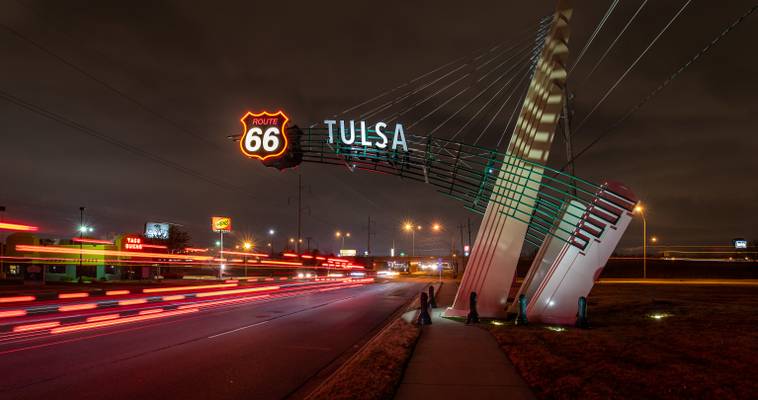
[395, 281, 534, 400]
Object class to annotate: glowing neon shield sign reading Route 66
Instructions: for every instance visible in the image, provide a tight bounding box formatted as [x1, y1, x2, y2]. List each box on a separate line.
[240, 110, 289, 161]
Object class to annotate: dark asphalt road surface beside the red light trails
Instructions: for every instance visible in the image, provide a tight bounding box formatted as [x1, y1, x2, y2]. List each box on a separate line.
[0, 282, 423, 400]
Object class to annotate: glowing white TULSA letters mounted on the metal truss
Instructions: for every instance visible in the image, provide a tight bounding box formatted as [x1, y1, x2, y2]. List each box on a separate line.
[324, 119, 408, 151]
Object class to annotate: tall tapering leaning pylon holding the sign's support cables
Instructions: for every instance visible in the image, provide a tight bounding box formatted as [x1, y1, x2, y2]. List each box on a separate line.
[445, 0, 572, 317]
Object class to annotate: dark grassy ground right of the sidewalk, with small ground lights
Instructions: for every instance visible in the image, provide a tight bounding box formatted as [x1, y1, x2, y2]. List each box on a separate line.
[490, 285, 758, 399]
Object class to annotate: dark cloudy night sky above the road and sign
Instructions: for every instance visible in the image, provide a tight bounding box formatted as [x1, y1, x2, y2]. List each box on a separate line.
[0, 0, 758, 254]
